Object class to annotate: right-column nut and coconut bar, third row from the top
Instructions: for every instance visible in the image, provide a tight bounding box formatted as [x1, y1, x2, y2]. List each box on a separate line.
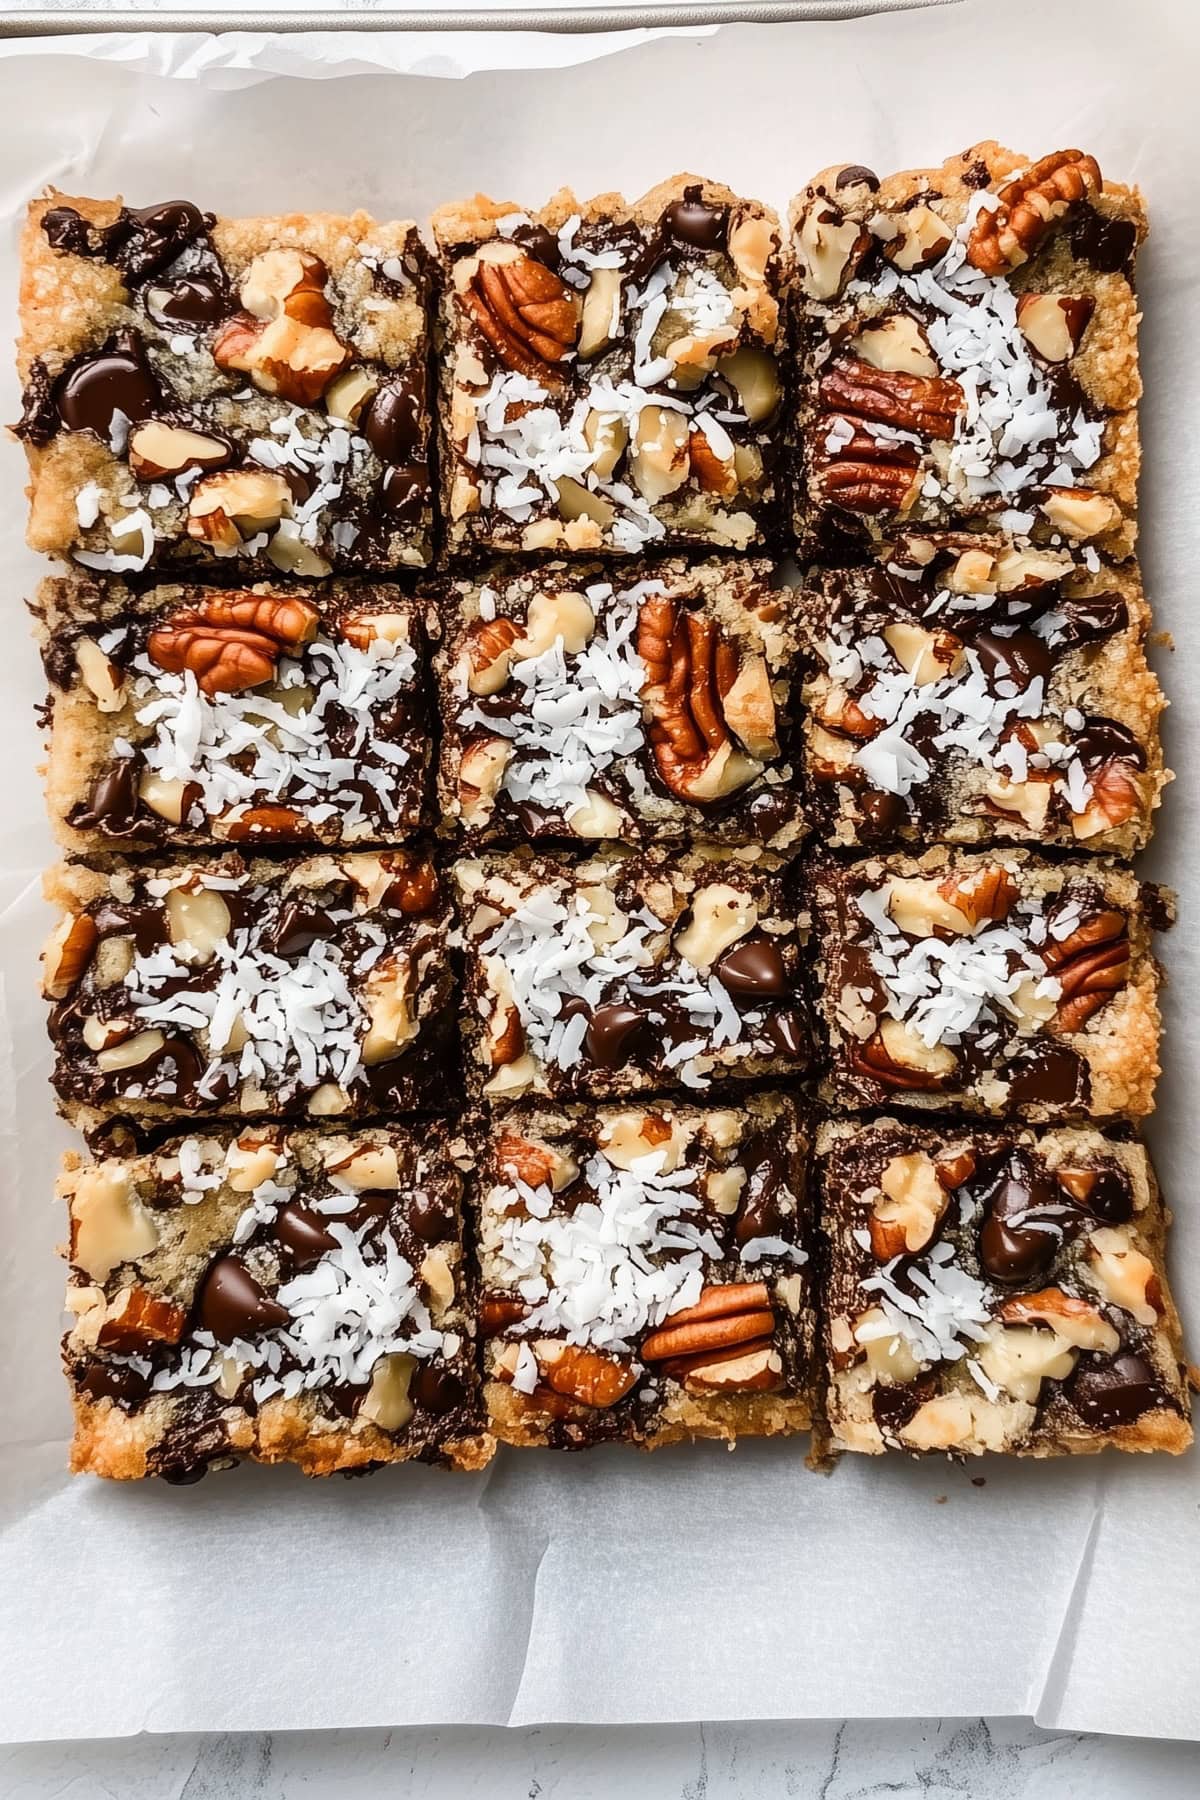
[813, 848, 1164, 1120]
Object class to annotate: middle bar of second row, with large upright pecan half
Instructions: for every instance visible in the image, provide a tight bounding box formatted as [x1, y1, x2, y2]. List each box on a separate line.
[437, 560, 804, 850]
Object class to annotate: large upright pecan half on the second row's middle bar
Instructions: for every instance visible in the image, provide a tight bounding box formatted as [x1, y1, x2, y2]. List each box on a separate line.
[637, 594, 774, 801]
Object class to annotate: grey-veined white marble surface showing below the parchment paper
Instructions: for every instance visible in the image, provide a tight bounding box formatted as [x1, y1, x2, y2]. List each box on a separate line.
[0, 0, 1200, 1800]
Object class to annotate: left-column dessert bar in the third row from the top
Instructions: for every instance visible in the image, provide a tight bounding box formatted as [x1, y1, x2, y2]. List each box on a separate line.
[43, 850, 453, 1132]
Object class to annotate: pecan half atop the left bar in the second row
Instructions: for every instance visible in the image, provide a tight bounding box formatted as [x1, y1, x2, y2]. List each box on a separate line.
[146, 592, 320, 698]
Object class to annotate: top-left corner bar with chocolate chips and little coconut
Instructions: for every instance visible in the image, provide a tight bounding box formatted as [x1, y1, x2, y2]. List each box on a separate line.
[18, 193, 434, 576]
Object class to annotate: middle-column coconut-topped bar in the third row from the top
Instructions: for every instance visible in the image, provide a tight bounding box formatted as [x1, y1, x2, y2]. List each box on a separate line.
[453, 850, 811, 1103]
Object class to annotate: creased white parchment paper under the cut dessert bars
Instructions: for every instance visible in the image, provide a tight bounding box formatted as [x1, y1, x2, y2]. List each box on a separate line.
[0, 0, 1200, 1739]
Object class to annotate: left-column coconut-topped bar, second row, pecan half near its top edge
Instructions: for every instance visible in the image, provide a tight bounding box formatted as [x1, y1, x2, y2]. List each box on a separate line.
[32, 576, 430, 851]
